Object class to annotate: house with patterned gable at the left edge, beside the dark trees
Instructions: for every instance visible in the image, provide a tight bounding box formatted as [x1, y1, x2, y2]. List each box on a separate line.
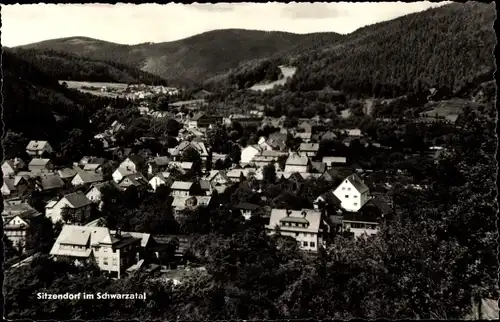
[2, 209, 41, 252]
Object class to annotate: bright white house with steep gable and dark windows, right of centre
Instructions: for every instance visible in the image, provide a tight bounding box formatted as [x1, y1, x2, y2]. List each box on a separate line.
[333, 173, 370, 212]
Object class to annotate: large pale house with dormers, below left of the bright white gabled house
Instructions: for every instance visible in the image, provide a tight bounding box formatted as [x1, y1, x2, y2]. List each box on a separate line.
[265, 209, 326, 252]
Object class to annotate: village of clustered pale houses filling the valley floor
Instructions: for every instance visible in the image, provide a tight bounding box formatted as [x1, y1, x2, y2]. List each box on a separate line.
[2, 85, 458, 278]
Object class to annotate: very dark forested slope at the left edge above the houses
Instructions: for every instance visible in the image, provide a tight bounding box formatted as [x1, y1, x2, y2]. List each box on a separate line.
[2, 51, 123, 165]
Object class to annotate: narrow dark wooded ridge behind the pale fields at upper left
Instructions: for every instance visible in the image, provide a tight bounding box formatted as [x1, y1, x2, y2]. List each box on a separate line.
[9, 48, 167, 85]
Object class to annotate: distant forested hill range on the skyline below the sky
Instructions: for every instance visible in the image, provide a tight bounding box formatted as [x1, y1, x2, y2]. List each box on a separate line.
[17, 29, 343, 85]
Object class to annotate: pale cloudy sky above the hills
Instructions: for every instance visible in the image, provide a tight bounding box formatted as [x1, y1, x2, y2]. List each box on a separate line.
[1, 1, 450, 47]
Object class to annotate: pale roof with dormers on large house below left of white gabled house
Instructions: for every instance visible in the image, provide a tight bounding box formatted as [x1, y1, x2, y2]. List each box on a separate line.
[266, 209, 321, 234]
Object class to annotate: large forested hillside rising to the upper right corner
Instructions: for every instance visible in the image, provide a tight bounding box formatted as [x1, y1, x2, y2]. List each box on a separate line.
[290, 2, 496, 97]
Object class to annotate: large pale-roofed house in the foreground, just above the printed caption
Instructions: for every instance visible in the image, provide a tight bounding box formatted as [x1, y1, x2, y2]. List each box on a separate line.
[50, 225, 142, 278]
